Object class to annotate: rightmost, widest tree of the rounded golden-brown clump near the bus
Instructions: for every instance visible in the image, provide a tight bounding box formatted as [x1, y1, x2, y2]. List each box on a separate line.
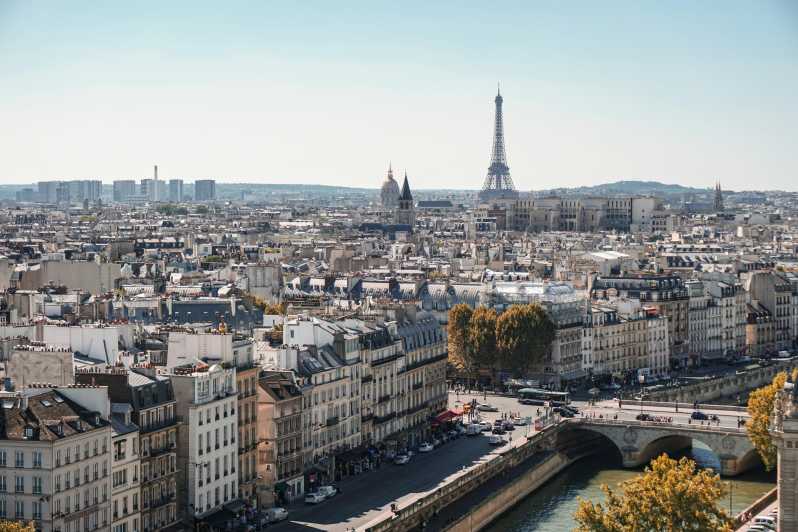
[496, 303, 555, 377]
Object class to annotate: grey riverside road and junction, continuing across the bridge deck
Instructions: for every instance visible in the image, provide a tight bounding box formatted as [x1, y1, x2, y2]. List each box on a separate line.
[269, 392, 752, 532]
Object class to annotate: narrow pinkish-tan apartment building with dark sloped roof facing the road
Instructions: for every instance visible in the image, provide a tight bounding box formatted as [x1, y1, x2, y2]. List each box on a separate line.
[257, 371, 305, 508]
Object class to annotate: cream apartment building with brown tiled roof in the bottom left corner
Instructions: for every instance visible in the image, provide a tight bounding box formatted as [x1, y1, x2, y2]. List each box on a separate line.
[0, 386, 112, 532]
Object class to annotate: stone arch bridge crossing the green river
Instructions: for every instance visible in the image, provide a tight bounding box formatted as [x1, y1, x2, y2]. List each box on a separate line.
[563, 418, 760, 477]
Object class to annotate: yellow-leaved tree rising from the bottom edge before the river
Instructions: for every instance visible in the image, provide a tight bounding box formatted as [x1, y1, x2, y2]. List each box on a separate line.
[574, 454, 732, 532]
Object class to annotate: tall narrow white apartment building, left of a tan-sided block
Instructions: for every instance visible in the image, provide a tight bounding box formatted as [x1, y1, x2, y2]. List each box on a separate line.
[170, 362, 238, 522]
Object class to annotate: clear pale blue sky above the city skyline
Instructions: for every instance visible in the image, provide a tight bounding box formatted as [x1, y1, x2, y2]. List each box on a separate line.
[0, 0, 798, 190]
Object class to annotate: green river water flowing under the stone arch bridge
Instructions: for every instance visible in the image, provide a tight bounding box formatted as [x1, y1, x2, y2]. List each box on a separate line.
[486, 441, 776, 532]
